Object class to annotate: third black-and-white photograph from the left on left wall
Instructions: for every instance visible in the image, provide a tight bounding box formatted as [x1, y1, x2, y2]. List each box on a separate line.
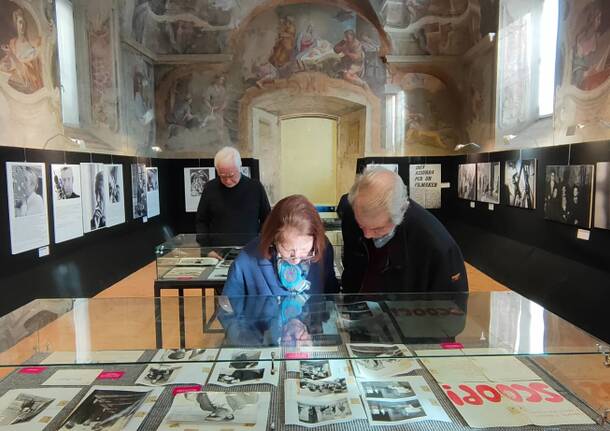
[81, 163, 108, 232]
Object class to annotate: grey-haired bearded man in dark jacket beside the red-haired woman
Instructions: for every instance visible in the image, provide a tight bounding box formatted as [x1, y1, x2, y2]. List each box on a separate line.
[341, 168, 468, 293]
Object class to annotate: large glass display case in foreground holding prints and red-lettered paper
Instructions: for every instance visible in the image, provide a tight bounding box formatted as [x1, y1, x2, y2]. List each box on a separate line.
[0, 292, 610, 430]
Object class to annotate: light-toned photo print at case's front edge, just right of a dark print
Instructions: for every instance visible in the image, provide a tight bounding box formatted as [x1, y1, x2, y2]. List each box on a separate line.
[158, 391, 271, 431]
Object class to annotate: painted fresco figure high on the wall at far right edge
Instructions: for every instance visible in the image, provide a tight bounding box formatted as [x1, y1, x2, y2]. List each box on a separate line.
[572, 0, 610, 90]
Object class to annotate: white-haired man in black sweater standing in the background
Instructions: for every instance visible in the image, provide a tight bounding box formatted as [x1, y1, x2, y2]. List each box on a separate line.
[196, 147, 271, 240]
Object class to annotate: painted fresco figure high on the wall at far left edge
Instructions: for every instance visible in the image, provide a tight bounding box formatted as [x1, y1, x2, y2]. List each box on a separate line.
[0, 9, 43, 94]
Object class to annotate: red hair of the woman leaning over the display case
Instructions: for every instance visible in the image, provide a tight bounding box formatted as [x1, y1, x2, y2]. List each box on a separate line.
[259, 195, 326, 262]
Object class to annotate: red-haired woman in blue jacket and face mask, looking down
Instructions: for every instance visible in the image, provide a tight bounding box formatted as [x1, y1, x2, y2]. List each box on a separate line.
[223, 195, 339, 296]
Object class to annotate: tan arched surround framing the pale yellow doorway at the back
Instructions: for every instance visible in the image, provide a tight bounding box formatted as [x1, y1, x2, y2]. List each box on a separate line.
[240, 73, 380, 203]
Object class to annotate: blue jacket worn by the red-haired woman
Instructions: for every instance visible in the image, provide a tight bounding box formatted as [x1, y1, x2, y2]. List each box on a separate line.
[222, 238, 339, 296]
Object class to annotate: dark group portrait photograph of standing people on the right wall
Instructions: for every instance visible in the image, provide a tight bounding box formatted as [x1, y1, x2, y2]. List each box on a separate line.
[544, 165, 594, 228]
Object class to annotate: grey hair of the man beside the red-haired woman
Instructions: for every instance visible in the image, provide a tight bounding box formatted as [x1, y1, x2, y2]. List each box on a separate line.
[348, 167, 409, 225]
